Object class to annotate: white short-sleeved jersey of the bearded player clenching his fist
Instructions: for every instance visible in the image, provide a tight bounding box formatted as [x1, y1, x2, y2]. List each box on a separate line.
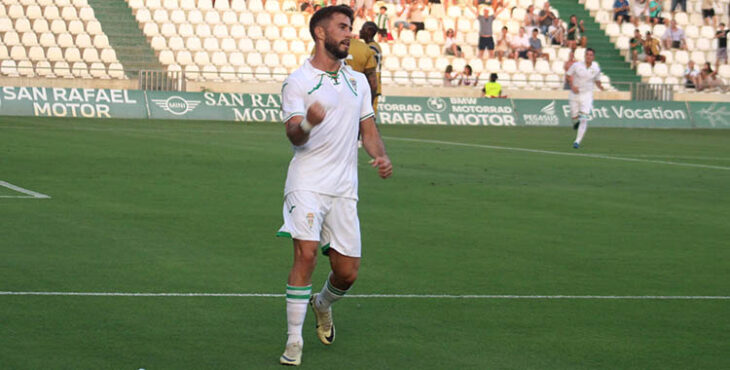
[281, 60, 374, 199]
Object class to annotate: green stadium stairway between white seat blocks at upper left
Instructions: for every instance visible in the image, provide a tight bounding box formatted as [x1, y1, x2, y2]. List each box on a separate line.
[88, 0, 164, 78]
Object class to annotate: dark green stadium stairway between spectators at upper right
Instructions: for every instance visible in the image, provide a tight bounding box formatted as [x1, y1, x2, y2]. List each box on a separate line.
[550, 0, 641, 91]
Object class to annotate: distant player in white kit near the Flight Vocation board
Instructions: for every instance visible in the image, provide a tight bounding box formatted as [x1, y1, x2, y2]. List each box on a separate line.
[565, 48, 603, 149]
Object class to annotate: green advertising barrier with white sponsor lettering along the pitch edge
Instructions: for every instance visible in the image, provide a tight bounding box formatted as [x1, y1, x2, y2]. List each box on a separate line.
[0, 87, 730, 128]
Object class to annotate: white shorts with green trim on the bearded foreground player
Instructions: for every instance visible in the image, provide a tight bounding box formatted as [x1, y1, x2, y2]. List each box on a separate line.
[276, 191, 361, 257]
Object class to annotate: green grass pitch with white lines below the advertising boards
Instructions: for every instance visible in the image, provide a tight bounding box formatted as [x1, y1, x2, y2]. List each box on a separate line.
[0, 117, 730, 370]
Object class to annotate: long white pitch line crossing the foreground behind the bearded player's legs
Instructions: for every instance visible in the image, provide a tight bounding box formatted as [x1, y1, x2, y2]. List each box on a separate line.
[0, 292, 730, 300]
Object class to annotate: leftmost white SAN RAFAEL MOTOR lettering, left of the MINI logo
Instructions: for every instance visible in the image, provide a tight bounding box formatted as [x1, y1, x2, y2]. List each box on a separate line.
[2, 87, 137, 118]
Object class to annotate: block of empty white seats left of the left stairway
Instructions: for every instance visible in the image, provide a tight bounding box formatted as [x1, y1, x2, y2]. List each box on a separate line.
[0, 0, 125, 79]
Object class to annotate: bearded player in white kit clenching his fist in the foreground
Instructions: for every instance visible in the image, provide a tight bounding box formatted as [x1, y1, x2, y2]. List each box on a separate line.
[277, 5, 393, 365]
